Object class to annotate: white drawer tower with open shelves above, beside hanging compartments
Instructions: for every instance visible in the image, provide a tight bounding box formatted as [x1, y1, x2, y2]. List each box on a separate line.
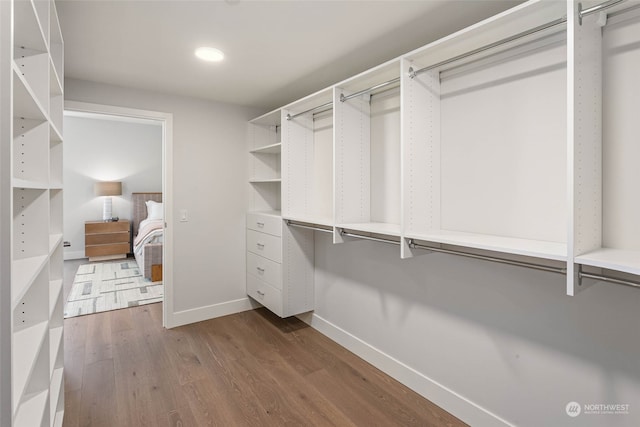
[246, 110, 314, 317]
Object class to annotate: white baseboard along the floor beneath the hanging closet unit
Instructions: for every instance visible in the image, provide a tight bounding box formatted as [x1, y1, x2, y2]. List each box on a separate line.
[297, 313, 511, 427]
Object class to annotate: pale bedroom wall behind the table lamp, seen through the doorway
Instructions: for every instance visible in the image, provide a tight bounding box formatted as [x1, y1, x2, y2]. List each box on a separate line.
[63, 115, 162, 259]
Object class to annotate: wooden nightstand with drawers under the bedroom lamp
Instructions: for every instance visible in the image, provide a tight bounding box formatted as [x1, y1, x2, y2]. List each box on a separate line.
[84, 220, 131, 261]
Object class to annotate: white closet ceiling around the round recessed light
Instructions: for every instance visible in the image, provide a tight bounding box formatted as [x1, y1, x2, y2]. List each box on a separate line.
[56, 0, 520, 110]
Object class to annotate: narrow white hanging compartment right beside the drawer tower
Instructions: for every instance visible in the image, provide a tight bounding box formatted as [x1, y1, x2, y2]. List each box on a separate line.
[282, 89, 334, 226]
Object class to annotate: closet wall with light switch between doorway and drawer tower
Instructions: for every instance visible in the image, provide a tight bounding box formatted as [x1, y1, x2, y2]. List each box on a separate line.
[65, 79, 259, 324]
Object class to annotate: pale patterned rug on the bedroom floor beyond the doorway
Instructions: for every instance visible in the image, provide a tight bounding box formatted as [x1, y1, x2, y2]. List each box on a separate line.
[64, 259, 164, 319]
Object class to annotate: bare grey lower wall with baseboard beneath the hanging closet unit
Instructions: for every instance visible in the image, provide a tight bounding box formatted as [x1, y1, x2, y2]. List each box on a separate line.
[306, 233, 640, 427]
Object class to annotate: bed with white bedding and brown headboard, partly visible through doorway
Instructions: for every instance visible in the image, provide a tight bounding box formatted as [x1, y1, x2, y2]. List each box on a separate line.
[131, 193, 164, 281]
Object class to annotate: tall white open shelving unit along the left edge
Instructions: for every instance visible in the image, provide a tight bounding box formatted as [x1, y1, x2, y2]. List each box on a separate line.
[0, 0, 64, 427]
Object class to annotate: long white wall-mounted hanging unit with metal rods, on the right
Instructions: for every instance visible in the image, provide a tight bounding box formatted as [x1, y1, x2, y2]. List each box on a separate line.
[246, 0, 640, 295]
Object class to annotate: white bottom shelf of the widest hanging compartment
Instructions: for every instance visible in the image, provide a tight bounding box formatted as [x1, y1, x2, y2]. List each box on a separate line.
[405, 230, 567, 261]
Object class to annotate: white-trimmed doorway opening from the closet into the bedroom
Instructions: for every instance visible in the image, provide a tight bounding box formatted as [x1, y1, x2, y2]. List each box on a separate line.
[64, 101, 173, 327]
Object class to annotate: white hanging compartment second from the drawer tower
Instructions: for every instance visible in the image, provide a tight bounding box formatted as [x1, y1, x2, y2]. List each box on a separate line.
[334, 60, 401, 242]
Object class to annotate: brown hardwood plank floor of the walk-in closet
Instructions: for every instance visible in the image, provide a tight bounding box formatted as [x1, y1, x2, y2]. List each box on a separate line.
[64, 263, 465, 427]
